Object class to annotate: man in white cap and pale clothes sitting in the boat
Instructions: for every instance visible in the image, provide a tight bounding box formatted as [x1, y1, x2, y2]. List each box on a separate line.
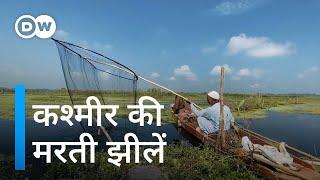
[191, 91, 234, 134]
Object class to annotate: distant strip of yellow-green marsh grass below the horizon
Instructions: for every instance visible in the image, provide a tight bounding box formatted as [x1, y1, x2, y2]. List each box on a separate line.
[0, 90, 320, 122]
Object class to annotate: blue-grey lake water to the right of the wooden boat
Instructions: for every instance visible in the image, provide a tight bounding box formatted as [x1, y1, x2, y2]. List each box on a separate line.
[238, 111, 320, 156]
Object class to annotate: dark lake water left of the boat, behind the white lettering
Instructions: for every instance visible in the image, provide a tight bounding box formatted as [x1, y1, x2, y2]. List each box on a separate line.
[0, 120, 188, 155]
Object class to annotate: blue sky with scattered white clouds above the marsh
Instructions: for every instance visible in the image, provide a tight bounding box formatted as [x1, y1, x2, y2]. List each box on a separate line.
[0, 0, 320, 93]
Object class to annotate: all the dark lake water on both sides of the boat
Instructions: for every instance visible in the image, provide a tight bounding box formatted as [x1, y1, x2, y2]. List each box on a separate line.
[0, 111, 320, 156]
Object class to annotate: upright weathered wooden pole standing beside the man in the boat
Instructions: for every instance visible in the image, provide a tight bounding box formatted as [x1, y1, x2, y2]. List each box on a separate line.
[217, 66, 225, 149]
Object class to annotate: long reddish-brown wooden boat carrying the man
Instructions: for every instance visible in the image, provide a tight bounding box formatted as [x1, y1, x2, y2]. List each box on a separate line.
[172, 96, 320, 180]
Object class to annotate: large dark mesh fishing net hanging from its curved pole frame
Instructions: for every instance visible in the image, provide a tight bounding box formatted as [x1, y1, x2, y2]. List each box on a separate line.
[53, 39, 138, 134]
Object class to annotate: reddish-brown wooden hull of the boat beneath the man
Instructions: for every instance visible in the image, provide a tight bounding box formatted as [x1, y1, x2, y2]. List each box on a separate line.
[172, 99, 320, 180]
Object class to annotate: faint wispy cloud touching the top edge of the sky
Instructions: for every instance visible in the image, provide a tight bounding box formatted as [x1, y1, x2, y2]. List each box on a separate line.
[210, 0, 256, 15]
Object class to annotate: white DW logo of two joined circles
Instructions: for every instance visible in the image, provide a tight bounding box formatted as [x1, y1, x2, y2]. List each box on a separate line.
[15, 15, 57, 39]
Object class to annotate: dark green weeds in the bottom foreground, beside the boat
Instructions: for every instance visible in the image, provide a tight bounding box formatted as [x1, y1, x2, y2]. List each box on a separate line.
[18, 142, 257, 179]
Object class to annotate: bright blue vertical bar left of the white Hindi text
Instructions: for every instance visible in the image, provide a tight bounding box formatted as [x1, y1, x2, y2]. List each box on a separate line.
[15, 85, 26, 170]
